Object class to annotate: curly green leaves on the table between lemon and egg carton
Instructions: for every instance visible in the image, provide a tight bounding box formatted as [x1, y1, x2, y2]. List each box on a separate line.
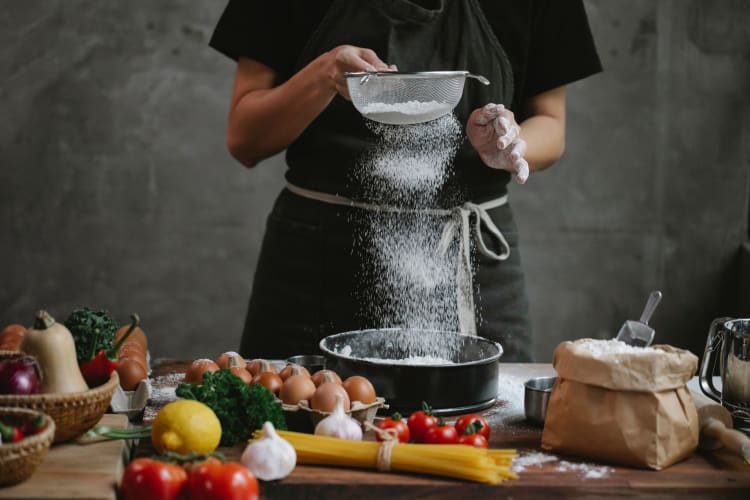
[176, 368, 286, 446]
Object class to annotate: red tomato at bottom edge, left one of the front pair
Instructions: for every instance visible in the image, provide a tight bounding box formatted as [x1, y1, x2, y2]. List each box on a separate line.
[120, 458, 187, 500]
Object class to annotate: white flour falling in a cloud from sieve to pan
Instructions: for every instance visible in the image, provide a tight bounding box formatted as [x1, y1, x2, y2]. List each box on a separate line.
[355, 114, 463, 348]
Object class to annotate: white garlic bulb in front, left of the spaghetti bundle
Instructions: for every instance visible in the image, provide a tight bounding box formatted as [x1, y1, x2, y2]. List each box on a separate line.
[240, 422, 297, 481]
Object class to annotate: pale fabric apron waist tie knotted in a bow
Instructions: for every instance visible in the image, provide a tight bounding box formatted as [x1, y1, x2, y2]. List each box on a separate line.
[286, 184, 510, 335]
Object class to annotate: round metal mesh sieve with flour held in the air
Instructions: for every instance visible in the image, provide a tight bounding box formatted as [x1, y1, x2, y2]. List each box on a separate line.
[344, 71, 490, 125]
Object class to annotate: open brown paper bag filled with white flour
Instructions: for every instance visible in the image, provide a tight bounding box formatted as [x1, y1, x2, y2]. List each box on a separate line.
[542, 339, 698, 470]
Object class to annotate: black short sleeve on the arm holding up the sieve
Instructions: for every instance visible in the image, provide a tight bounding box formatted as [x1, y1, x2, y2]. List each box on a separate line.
[209, 0, 328, 79]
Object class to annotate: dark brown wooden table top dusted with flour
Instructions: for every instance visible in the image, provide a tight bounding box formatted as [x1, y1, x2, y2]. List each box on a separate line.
[136, 360, 750, 500]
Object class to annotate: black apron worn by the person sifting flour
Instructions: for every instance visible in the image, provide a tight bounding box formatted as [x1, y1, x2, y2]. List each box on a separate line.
[240, 0, 531, 361]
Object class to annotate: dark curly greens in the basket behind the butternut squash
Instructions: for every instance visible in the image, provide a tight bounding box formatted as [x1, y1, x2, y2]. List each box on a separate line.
[63, 307, 119, 363]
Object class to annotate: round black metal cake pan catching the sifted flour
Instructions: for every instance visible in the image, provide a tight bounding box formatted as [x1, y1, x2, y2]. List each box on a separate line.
[320, 328, 503, 415]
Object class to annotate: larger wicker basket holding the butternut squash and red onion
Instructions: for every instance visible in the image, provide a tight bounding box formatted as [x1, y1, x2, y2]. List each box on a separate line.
[0, 353, 120, 443]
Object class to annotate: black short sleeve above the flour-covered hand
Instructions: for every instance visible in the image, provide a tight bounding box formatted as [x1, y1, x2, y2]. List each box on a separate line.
[524, 0, 602, 97]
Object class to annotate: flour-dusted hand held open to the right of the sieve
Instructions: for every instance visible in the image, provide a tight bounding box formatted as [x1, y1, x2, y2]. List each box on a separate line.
[466, 103, 529, 184]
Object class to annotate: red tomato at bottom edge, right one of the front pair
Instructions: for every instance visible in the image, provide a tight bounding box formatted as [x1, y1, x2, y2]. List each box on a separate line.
[188, 458, 258, 500]
